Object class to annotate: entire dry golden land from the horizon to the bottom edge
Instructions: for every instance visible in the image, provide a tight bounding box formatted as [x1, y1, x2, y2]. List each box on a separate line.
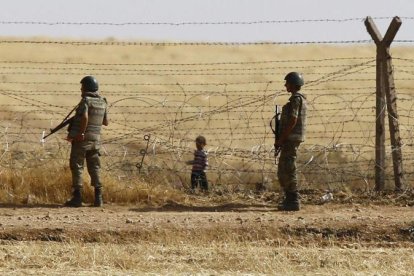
[0, 38, 414, 275]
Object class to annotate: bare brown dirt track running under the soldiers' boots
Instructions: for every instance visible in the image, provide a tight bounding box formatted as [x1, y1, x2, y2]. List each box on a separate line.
[0, 194, 414, 247]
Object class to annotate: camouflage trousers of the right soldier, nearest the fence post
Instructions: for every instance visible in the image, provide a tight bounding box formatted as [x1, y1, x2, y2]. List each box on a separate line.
[277, 142, 300, 193]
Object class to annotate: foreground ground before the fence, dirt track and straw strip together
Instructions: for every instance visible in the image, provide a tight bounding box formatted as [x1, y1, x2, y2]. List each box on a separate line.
[0, 198, 414, 275]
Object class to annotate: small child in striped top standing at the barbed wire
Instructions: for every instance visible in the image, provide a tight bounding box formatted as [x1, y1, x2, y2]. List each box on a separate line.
[187, 136, 208, 191]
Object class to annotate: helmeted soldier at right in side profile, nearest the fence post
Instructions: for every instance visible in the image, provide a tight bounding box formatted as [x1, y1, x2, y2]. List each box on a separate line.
[275, 72, 307, 211]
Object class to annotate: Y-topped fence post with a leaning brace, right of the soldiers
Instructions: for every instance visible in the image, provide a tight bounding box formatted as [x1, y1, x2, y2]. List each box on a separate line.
[365, 17, 404, 191]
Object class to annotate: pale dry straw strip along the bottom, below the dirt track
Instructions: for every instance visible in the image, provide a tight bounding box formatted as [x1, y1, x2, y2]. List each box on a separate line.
[0, 239, 414, 275]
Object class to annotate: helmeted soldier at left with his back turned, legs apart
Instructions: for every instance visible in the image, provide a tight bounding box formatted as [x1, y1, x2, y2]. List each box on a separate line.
[65, 76, 108, 207]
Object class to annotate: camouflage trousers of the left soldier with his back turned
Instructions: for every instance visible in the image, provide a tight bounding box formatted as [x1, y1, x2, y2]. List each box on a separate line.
[69, 141, 102, 190]
